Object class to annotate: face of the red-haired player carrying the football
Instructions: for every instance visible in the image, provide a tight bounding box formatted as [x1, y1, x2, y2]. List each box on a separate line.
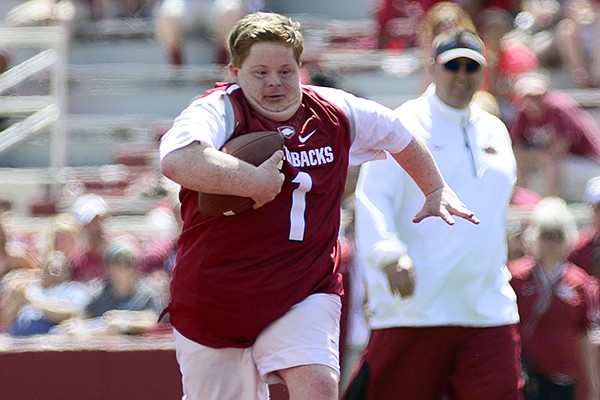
[229, 42, 302, 121]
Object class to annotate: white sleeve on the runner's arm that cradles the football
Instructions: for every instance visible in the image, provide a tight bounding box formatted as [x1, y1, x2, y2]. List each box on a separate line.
[160, 92, 231, 160]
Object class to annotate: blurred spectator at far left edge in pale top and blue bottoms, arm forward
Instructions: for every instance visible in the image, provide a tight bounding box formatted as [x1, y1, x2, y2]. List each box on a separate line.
[2, 251, 89, 336]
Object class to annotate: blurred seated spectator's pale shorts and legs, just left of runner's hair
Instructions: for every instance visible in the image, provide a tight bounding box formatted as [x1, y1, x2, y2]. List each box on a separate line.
[154, 0, 262, 65]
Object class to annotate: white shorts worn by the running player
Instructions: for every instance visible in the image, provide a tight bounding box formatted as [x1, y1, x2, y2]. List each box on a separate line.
[173, 293, 342, 400]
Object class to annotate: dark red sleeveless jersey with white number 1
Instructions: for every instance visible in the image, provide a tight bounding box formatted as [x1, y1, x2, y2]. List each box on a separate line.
[169, 85, 351, 348]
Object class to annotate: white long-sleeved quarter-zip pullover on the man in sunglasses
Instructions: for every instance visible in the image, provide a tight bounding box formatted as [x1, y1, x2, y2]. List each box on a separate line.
[356, 87, 518, 329]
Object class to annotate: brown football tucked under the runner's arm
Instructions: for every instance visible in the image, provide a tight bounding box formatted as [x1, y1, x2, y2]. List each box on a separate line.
[198, 131, 283, 217]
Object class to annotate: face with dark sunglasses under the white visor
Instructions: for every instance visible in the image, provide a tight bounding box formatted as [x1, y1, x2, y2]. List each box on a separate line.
[432, 57, 483, 108]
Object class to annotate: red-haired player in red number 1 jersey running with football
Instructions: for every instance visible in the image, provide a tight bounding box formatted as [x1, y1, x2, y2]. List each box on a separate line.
[160, 13, 479, 400]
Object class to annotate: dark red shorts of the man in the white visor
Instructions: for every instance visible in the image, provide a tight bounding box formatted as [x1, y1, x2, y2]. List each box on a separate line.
[343, 325, 523, 400]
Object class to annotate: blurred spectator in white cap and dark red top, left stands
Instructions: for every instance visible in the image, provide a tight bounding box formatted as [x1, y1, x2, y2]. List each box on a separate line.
[71, 193, 109, 281]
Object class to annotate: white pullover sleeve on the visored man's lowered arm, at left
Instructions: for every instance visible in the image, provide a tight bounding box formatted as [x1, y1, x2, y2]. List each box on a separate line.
[355, 157, 407, 270]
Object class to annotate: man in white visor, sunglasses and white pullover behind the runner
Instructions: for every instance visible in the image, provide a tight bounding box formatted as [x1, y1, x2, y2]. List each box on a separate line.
[344, 30, 523, 400]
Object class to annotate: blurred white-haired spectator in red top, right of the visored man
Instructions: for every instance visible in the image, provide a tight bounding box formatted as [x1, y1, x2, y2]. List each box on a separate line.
[509, 197, 600, 400]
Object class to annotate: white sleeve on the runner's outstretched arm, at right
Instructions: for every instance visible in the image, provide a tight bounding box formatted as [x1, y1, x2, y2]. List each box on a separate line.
[314, 87, 412, 165]
